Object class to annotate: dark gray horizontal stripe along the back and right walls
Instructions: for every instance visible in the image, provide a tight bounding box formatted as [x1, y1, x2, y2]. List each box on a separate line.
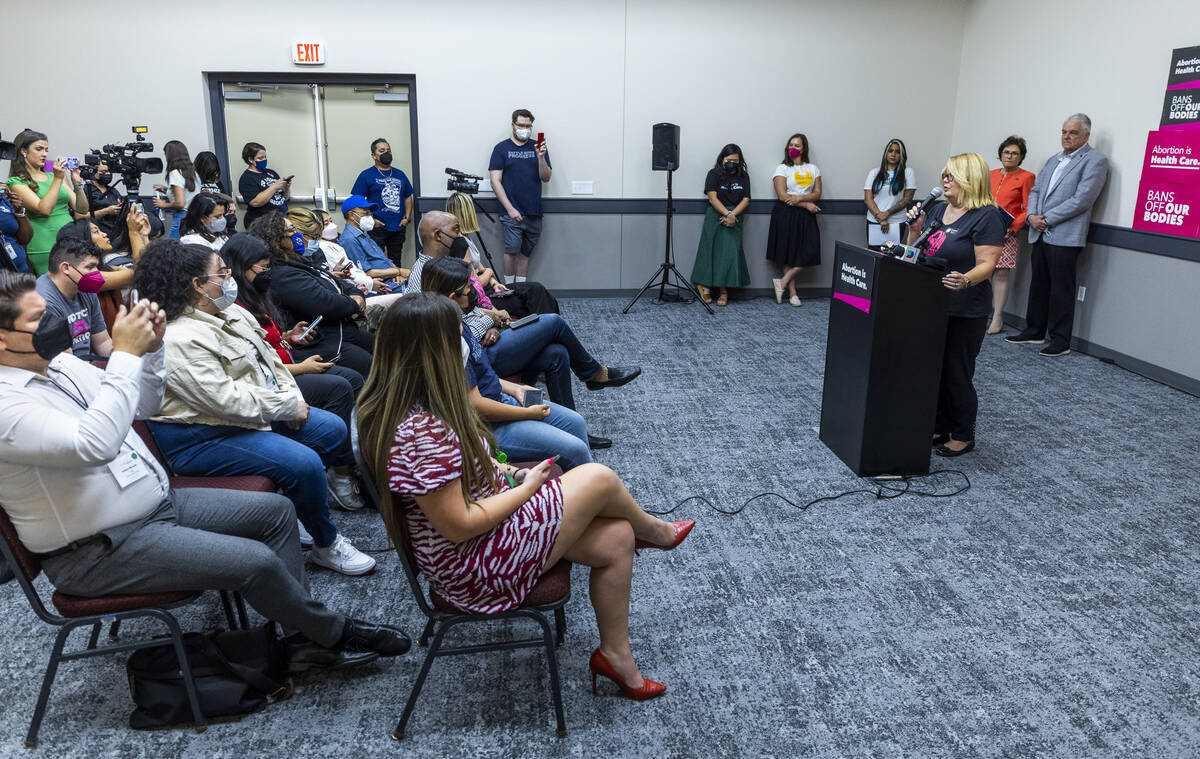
[418, 197, 1200, 262]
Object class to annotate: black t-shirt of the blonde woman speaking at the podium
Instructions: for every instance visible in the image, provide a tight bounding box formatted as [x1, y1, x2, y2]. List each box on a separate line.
[925, 201, 1008, 318]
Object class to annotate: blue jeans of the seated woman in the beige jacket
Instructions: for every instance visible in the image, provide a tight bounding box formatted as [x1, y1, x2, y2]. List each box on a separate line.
[150, 408, 348, 548]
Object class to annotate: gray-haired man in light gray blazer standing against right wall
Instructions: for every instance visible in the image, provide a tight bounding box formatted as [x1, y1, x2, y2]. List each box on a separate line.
[1006, 113, 1109, 357]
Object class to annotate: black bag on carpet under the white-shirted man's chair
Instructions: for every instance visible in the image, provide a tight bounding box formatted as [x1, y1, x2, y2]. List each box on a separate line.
[125, 622, 292, 730]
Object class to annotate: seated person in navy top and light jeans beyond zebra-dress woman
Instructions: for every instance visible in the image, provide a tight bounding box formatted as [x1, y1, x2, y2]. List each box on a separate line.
[421, 257, 592, 470]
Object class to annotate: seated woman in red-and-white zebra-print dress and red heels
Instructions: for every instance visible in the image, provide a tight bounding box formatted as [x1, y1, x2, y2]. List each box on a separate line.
[359, 293, 691, 699]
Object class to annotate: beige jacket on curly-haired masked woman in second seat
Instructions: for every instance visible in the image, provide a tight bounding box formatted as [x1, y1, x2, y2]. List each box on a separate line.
[154, 305, 302, 430]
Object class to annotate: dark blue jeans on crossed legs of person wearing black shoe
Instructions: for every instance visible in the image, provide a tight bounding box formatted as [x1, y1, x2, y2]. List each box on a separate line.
[485, 313, 604, 410]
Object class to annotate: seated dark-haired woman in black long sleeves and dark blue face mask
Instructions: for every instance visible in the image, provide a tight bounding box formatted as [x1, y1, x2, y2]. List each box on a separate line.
[248, 214, 374, 376]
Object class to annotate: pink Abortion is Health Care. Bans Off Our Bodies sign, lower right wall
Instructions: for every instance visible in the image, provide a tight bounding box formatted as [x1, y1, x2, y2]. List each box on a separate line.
[1133, 130, 1200, 238]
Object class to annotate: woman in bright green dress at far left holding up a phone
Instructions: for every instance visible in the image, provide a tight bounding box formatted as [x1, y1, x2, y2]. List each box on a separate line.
[7, 130, 88, 274]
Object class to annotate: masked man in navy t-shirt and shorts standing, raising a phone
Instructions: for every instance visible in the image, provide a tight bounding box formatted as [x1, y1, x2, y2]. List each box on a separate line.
[487, 108, 551, 285]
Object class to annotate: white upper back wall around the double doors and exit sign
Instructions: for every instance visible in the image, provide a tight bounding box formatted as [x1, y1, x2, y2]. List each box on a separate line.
[0, 0, 966, 206]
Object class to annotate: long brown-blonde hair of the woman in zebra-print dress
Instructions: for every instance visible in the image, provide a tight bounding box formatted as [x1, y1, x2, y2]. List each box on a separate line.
[358, 293, 496, 533]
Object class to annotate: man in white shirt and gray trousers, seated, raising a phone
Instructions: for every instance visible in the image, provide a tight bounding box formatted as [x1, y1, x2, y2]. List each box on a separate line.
[0, 267, 408, 670]
